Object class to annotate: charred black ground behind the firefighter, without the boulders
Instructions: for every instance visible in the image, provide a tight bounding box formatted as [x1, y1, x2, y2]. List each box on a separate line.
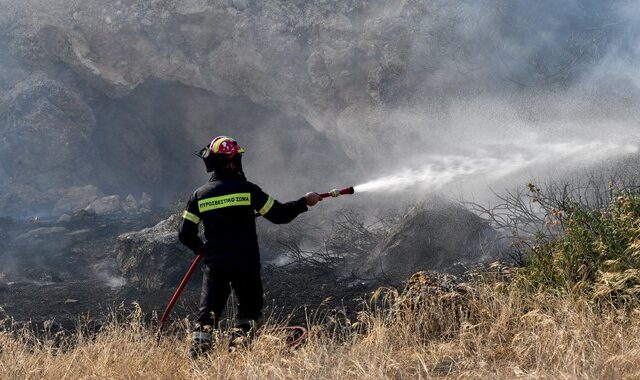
[0, 212, 400, 330]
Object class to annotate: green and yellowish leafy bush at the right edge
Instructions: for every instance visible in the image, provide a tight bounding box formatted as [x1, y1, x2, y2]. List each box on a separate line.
[520, 192, 640, 306]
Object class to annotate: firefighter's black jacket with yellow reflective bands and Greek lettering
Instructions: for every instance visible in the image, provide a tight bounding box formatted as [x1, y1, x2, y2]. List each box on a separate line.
[178, 171, 307, 270]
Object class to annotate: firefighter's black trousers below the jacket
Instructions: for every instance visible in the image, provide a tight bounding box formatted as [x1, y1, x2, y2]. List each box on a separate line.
[196, 264, 263, 328]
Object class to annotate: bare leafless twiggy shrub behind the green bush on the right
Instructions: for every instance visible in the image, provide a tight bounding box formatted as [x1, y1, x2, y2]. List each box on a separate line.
[466, 156, 640, 265]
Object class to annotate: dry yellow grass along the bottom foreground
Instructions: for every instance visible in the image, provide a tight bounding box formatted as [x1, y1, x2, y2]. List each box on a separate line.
[0, 285, 640, 379]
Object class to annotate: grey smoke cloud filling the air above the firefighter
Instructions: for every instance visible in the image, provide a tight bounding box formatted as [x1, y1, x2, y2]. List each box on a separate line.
[0, 0, 640, 211]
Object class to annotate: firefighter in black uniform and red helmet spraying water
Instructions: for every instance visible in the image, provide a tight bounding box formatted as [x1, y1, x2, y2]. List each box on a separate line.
[179, 136, 322, 355]
